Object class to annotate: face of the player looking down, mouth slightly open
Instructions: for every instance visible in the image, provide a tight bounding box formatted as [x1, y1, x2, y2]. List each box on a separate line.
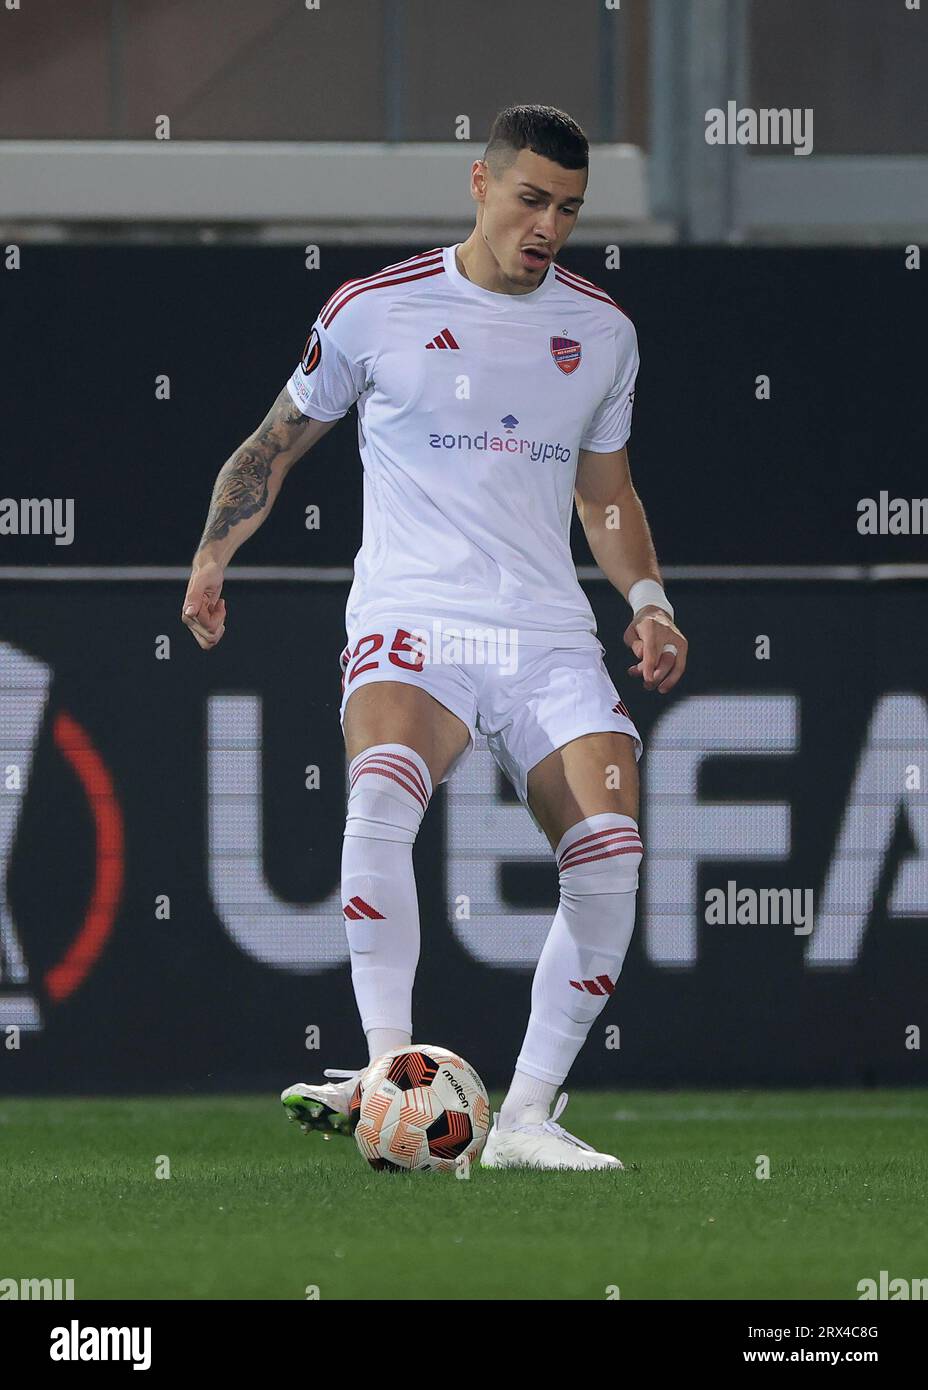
[482, 150, 586, 289]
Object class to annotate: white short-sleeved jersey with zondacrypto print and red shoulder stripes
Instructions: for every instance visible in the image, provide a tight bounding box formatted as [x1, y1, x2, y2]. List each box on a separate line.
[288, 246, 638, 646]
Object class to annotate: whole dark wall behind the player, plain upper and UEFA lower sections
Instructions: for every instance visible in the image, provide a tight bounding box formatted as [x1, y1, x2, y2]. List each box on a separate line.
[0, 239, 928, 1093]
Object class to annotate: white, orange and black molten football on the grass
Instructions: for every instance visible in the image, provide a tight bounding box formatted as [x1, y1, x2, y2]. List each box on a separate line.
[351, 1043, 490, 1173]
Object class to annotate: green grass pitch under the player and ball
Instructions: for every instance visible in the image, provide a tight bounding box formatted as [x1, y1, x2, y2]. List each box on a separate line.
[0, 1090, 928, 1300]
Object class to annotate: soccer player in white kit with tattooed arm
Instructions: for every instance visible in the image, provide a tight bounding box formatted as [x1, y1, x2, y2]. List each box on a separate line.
[183, 106, 686, 1169]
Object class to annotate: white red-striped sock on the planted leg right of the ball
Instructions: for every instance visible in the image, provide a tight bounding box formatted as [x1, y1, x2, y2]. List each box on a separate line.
[500, 812, 642, 1129]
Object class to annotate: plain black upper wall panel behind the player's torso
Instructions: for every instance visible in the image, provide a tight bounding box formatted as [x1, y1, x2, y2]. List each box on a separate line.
[0, 243, 928, 566]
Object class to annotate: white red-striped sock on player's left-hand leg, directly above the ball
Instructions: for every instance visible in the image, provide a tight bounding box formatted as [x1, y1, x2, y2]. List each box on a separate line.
[342, 744, 432, 1058]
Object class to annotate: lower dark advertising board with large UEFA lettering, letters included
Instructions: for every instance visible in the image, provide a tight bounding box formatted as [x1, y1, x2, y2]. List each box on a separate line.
[0, 575, 928, 1094]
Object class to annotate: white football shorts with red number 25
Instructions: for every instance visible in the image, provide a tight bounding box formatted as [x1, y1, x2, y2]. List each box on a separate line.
[339, 620, 642, 830]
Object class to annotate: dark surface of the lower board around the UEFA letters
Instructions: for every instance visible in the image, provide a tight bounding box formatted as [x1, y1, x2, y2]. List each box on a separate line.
[0, 569, 925, 1094]
